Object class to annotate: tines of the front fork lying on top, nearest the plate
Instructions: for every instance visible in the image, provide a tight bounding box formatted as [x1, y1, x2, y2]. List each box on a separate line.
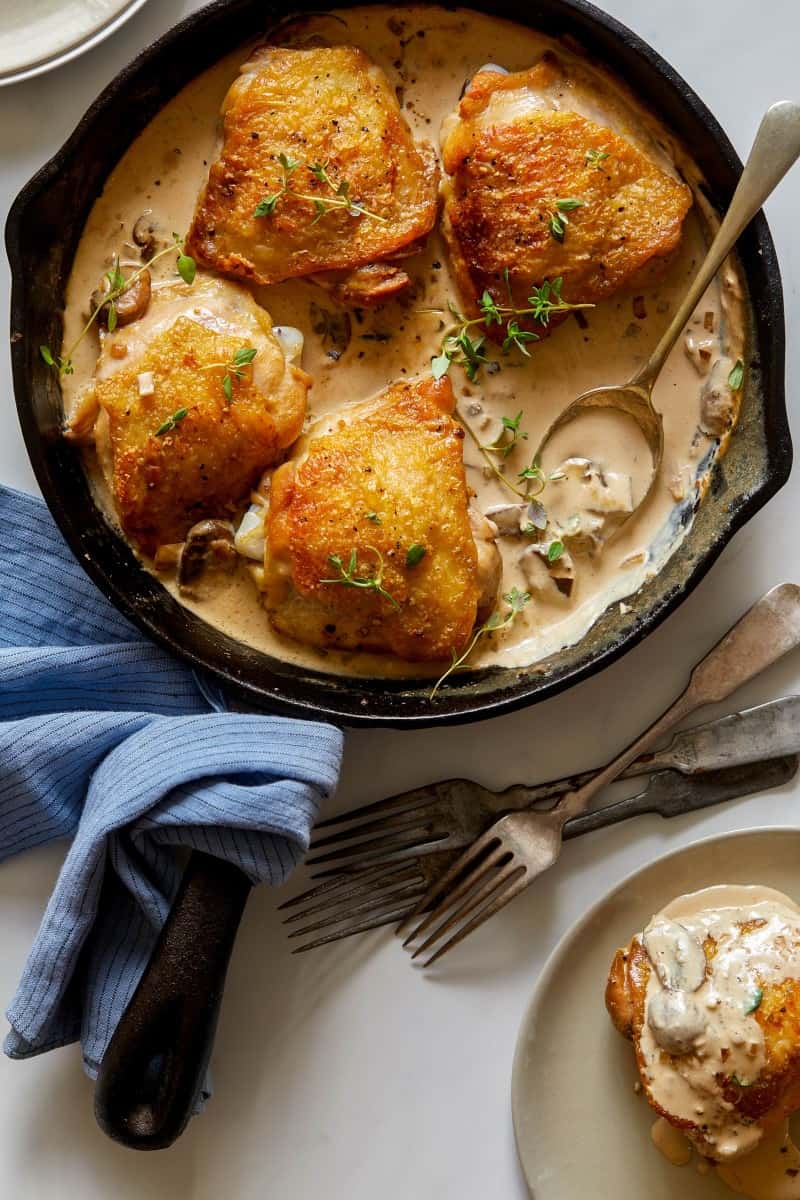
[396, 822, 528, 967]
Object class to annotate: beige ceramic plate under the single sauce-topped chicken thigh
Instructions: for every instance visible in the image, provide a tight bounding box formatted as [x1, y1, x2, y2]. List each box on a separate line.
[511, 828, 800, 1200]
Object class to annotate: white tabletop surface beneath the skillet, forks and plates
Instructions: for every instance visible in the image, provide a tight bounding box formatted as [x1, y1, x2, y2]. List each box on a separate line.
[0, 0, 800, 1200]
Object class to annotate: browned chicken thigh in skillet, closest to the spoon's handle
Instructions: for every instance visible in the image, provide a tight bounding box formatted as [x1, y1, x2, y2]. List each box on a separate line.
[443, 54, 692, 340]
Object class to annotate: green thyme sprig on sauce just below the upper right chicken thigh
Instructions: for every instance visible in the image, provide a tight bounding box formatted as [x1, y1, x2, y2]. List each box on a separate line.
[426, 274, 594, 383]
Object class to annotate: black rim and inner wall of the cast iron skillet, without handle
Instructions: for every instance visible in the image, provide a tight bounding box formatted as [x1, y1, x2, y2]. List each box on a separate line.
[6, 0, 792, 727]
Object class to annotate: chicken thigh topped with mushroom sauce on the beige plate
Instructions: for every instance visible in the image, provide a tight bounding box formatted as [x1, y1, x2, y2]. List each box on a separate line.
[606, 888, 800, 1162]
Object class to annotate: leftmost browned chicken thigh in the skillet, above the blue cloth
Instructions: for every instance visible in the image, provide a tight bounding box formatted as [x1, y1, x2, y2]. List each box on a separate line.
[73, 275, 311, 554]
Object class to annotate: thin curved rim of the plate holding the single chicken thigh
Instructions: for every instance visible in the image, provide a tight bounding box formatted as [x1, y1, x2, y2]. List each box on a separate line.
[511, 824, 800, 1200]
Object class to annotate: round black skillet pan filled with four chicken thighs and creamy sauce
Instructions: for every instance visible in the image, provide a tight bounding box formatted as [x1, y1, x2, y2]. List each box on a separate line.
[8, 0, 790, 722]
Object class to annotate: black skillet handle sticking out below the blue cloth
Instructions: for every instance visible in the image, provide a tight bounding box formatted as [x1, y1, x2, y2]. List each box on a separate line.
[95, 851, 251, 1150]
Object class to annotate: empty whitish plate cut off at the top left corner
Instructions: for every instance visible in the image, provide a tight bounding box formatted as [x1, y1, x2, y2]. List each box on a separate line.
[0, 0, 146, 86]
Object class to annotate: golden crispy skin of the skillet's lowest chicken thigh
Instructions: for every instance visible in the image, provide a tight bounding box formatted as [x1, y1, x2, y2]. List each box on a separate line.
[265, 378, 481, 661]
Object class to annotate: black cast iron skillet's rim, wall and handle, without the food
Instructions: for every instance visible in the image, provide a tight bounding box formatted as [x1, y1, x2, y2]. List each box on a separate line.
[6, 0, 792, 1148]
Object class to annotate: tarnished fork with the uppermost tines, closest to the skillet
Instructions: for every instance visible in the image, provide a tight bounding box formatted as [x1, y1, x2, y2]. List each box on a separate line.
[307, 696, 800, 878]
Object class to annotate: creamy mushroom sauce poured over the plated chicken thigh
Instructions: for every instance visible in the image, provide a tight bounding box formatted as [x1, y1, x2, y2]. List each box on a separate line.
[639, 887, 800, 1200]
